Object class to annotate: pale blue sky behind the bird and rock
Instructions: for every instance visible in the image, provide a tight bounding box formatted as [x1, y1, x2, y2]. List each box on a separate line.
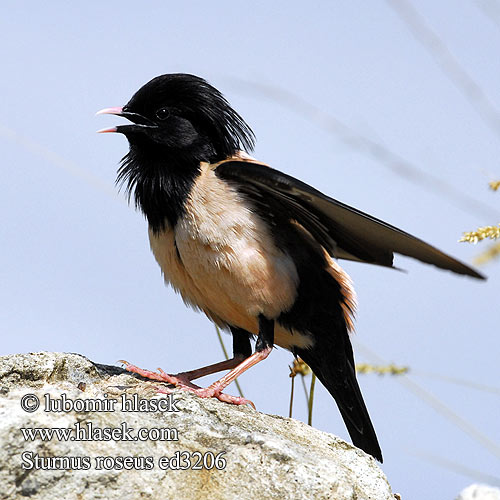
[0, 0, 500, 500]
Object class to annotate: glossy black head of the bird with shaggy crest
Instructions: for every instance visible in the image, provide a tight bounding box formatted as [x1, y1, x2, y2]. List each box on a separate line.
[98, 74, 254, 162]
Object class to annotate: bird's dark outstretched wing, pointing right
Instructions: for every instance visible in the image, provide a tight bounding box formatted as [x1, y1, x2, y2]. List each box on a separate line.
[215, 160, 485, 279]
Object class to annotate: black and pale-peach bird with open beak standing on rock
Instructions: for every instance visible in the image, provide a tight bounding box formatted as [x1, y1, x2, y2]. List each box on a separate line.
[96, 74, 483, 460]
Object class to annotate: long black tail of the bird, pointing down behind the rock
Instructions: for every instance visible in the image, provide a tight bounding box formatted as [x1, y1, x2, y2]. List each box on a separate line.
[295, 337, 383, 462]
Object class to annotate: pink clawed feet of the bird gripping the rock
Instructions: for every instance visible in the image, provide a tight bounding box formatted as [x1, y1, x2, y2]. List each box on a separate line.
[120, 360, 255, 410]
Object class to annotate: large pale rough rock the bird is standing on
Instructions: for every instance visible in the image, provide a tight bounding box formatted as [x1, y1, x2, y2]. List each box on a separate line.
[0, 352, 394, 500]
